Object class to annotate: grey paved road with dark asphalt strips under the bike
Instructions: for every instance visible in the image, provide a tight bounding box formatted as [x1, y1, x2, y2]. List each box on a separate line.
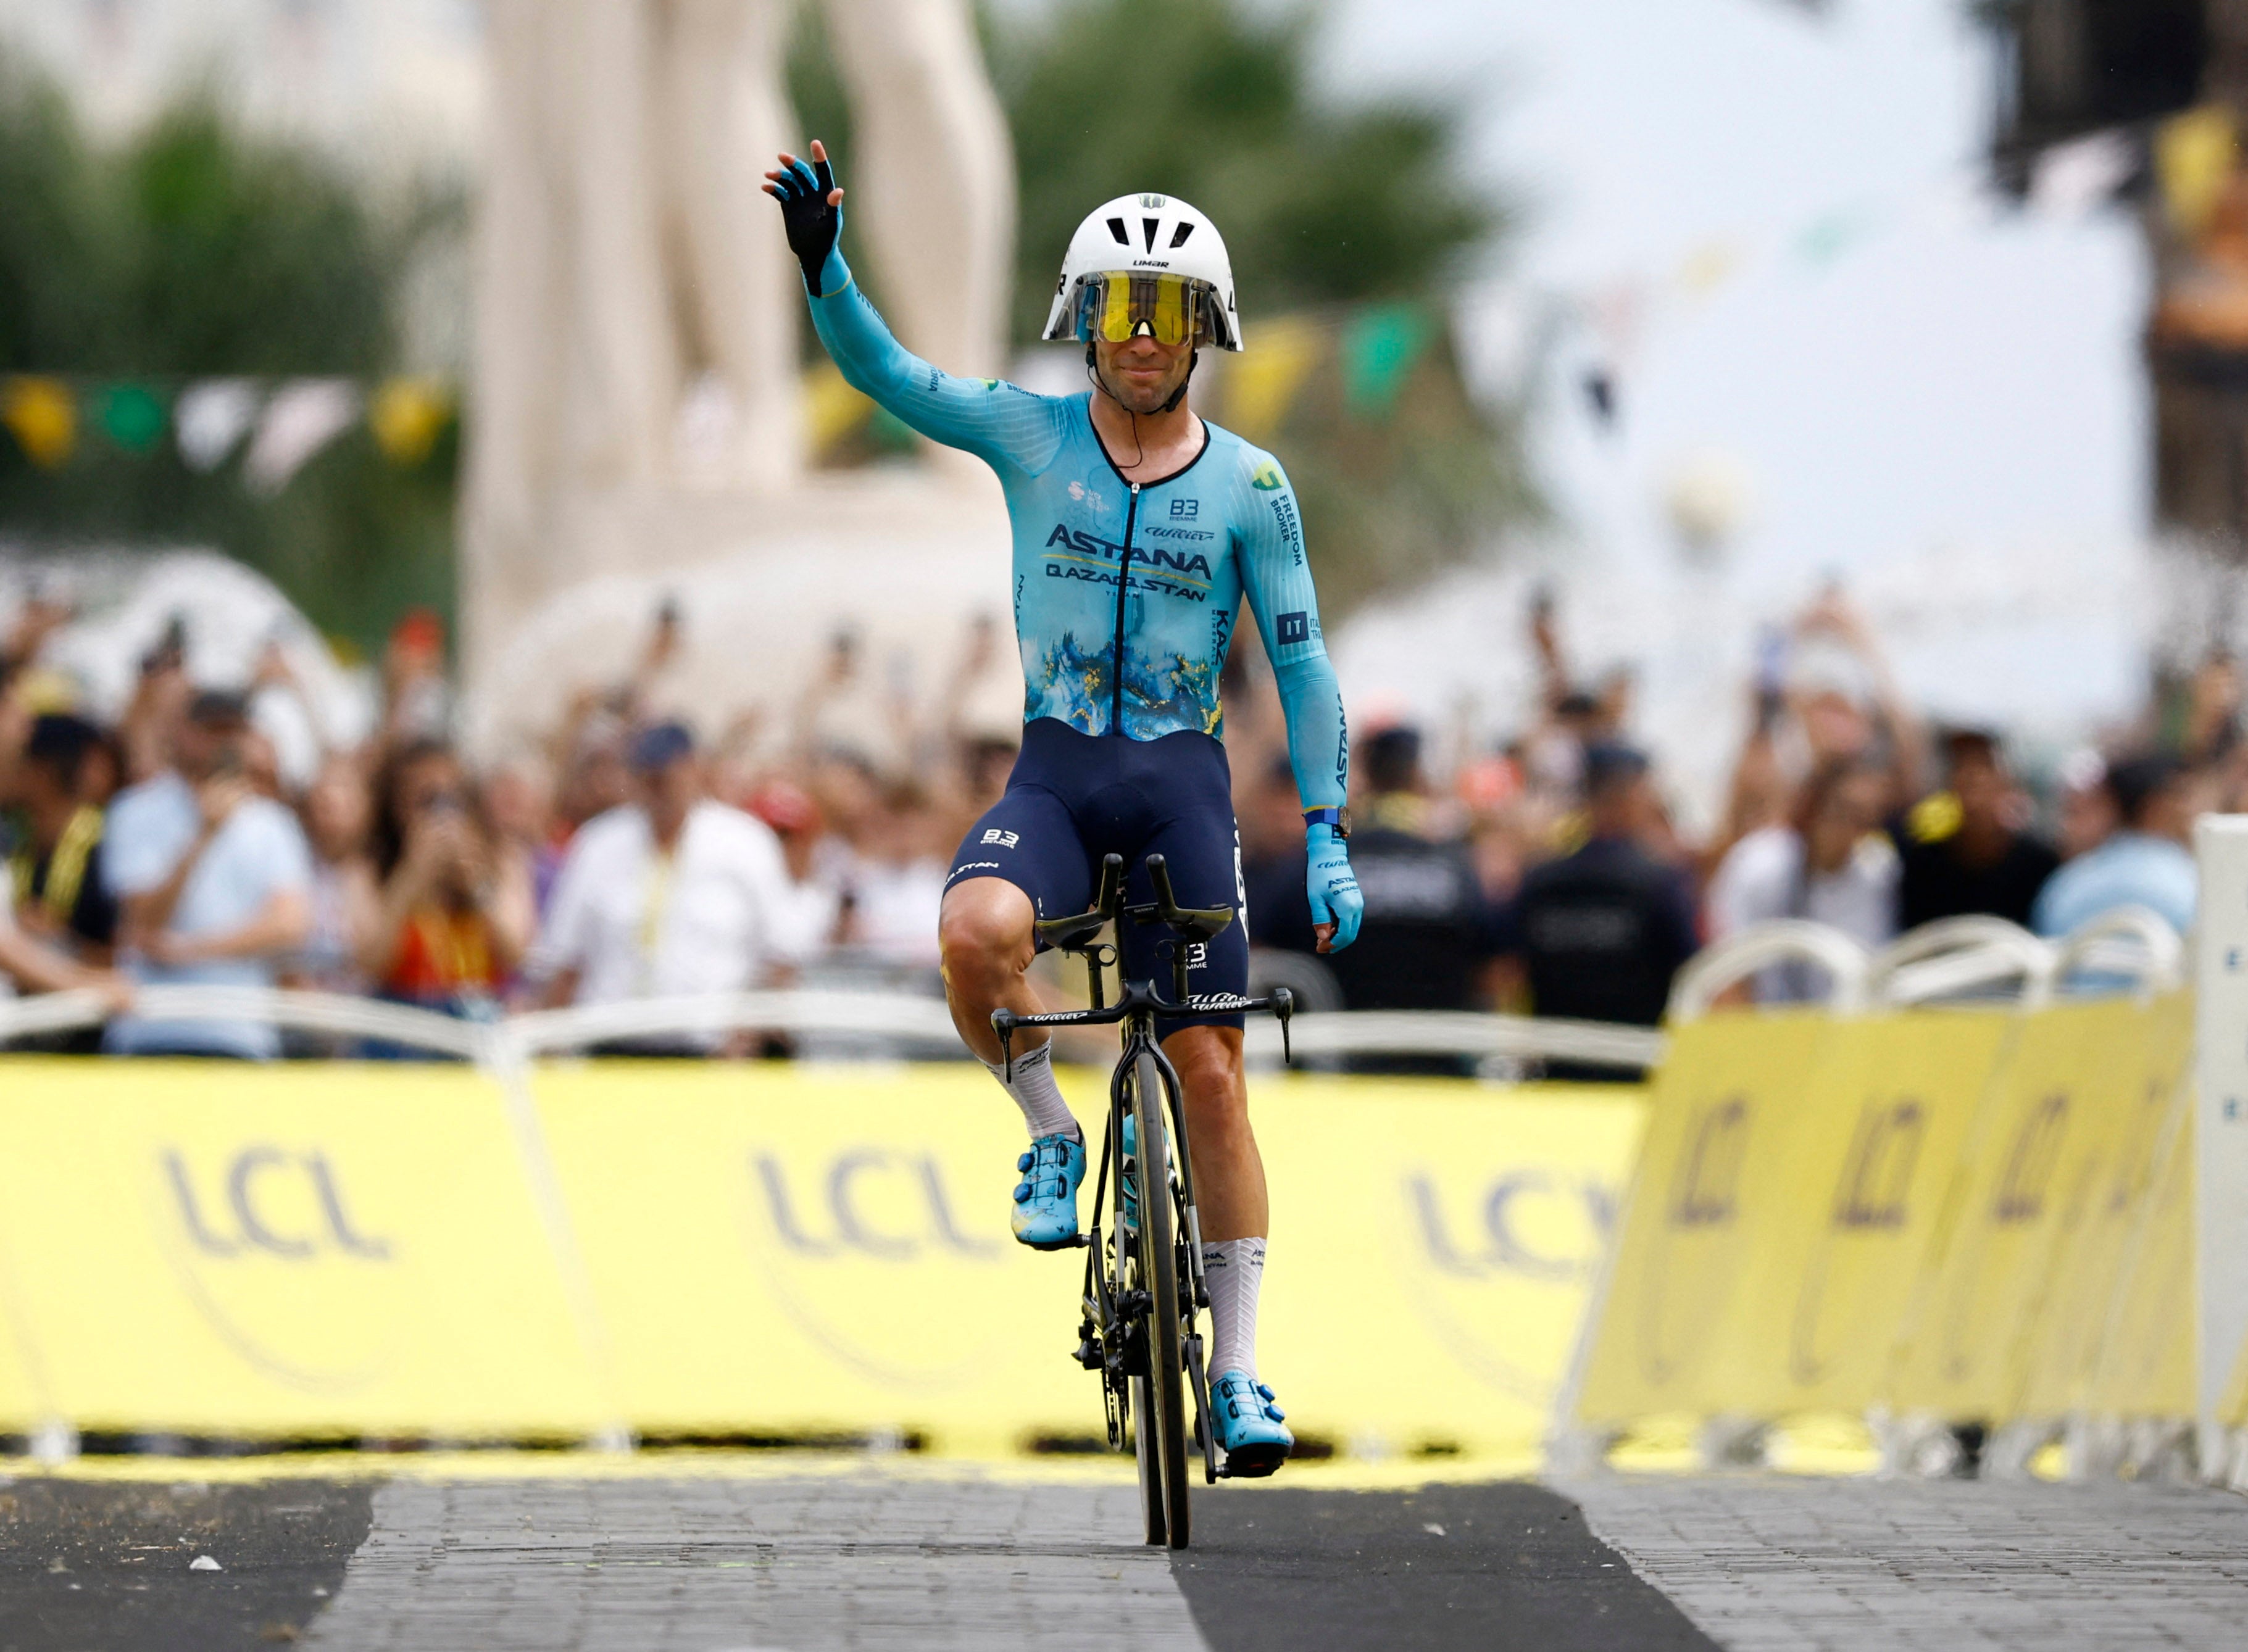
[0, 1467, 2248, 1652]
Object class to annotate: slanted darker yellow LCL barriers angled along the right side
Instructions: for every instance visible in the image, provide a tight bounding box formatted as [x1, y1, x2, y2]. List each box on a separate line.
[1567, 994, 2192, 1429]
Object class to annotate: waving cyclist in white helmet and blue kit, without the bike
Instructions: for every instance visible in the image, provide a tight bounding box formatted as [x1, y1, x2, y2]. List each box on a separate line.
[767, 144, 1362, 1474]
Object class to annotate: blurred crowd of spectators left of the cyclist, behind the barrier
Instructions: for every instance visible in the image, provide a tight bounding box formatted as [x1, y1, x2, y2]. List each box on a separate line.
[0, 602, 1020, 1058]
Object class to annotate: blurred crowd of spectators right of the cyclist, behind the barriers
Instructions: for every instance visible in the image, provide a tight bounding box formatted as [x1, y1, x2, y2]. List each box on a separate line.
[1234, 591, 2221, 1025]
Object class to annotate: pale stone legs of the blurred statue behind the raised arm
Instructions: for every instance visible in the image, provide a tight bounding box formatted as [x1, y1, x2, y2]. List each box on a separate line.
[465, 0, 1014, 674]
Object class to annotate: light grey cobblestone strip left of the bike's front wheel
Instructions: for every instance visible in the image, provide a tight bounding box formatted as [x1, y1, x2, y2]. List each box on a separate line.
[306, 1474, 1202, 1652]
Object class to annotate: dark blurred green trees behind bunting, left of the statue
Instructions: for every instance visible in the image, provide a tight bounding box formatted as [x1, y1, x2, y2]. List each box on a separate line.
[0, 53, 459, 647]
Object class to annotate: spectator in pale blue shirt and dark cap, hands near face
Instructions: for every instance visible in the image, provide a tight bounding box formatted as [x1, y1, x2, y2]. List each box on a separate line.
[104, 692, 312, 1061]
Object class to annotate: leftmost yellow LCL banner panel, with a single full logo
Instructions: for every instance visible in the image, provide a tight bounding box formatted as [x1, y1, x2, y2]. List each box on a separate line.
[0, 1056, 609, 1438]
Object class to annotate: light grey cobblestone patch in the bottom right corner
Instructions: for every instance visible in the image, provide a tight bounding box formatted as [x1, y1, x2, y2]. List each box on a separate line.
[1558, 1477, 2248, 1652]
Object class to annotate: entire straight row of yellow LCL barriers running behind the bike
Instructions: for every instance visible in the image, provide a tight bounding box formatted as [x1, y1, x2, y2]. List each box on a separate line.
[0, 1056, 1641, 1459]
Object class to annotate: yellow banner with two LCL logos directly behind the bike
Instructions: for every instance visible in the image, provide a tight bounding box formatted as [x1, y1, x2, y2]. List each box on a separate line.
[535, 1061, 1641, 1454]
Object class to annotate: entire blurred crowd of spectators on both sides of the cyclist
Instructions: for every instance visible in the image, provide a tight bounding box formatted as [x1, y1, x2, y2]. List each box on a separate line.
[0, 594, 2212, 1056]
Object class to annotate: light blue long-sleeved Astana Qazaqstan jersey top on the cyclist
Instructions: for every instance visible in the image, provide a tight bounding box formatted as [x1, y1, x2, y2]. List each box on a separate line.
[812, 254, 1351, 807]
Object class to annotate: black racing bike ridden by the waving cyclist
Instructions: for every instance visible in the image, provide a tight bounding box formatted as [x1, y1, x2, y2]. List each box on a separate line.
[991, 854, 1295, 1548]
